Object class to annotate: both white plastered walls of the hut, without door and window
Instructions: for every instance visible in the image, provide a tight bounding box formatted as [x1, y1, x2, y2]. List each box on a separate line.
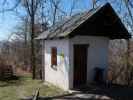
[44, 36, 109, 90]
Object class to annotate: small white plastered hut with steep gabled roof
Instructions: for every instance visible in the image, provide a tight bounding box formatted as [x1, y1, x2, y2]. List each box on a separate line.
[37, 3, 131, 90]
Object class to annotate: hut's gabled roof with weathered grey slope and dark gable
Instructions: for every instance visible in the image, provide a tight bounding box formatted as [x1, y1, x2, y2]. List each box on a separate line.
[37, 3, 131, 39]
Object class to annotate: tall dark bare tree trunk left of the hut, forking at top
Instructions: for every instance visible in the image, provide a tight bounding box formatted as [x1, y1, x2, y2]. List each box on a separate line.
[20, 0, 41, 79]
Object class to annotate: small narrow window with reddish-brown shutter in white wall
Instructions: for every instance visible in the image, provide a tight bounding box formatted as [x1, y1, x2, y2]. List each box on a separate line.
[51, 47, 57, 65]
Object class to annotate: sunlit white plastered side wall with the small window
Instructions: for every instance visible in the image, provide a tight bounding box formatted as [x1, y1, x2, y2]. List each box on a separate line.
[45, 39, 69, 90]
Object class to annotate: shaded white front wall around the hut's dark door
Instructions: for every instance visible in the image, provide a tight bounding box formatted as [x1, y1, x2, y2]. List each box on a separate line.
[69, 36, 109, 88]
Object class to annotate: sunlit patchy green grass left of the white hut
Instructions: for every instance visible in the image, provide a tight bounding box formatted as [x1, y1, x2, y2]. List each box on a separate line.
[0, 75, 64, 100]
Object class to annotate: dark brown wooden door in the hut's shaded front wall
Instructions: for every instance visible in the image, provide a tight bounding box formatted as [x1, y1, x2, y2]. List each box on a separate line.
[74, 45, 88, 88]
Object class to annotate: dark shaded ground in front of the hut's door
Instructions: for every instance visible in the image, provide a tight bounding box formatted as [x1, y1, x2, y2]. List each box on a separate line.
[36, 85, 133, 100]
